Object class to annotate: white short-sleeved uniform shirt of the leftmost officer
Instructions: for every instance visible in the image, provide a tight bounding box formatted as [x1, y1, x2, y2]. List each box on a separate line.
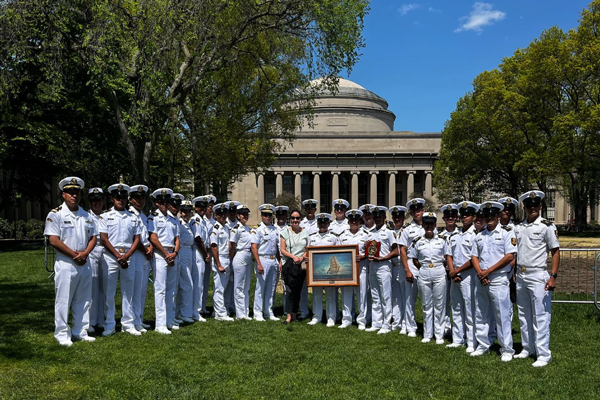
[44, 203, 98, 253]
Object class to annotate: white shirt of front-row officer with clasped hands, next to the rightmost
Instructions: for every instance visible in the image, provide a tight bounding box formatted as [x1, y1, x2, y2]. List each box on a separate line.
[471, 224, 517, 272]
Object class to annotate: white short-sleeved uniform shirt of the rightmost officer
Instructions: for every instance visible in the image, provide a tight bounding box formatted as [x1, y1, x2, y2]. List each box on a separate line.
[515, 217, 559, 268]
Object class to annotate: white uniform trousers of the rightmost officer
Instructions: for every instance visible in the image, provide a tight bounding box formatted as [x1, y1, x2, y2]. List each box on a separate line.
[517, 267, 552, 362]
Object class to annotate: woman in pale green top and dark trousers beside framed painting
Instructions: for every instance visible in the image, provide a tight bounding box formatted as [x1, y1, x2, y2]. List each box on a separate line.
[280, 210, 309, 324]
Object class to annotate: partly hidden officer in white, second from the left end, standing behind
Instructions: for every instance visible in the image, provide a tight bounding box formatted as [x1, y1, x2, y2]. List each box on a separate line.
[88, 187, 105, 333]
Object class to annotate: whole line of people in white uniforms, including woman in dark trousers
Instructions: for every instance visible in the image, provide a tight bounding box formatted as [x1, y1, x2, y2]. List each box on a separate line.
[44, 177, 560, 367]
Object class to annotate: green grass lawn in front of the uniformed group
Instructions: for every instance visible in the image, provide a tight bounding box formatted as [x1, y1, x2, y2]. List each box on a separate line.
[0, 250, 600, 399]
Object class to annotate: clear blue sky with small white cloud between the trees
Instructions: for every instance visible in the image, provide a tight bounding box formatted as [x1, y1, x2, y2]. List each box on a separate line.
[343, 0, 589, 132]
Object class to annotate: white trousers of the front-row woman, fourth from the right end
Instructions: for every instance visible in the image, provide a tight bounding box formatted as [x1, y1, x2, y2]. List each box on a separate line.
[419, 266, 447, 340]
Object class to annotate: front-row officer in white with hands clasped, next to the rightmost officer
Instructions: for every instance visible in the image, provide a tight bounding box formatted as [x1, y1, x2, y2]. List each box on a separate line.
[471, 201, 517, 362]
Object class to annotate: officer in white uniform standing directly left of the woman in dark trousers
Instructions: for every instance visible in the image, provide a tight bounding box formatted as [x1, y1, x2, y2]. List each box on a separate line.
[251, 204, 281, 321]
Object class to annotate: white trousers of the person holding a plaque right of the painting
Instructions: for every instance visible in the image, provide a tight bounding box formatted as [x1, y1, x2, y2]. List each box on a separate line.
[369, 261, 392, 329]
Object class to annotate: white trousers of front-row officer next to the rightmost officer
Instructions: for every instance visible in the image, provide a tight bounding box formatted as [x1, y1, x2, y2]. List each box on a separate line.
[475, 272, 515, 355]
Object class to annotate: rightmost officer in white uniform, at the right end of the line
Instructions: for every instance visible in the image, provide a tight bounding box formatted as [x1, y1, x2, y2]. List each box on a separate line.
[515, 190, 560, 367]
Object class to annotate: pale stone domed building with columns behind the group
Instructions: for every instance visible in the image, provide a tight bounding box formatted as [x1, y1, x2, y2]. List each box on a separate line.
[231, 79, 441, 221]
